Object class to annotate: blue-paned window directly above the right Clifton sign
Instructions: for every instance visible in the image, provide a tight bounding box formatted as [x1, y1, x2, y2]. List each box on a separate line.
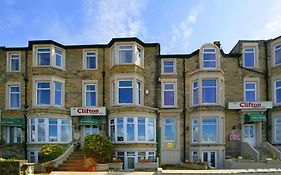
[244, 82, 257, 102]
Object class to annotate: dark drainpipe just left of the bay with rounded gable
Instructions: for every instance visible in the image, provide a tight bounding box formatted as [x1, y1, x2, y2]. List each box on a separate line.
[182, 58, 186, 162]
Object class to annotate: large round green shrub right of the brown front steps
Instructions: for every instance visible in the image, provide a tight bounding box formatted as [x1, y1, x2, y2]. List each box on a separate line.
[83, 134, 112, 163]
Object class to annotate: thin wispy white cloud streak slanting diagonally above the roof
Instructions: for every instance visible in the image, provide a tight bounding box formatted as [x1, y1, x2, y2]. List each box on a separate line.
[165, 1, 205, 52]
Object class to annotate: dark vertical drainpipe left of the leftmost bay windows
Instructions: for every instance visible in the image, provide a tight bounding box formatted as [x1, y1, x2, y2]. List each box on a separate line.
[23, 50, 28, 160]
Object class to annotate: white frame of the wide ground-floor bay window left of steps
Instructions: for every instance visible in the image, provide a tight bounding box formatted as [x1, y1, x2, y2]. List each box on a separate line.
[28, 118, 72, 144]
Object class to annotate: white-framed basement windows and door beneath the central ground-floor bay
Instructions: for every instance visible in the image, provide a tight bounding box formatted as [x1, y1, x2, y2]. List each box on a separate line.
[114, 151, 156, 169]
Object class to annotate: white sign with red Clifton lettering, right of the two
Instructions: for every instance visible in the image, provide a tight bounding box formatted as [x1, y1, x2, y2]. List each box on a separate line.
[228, 101, 272, 109]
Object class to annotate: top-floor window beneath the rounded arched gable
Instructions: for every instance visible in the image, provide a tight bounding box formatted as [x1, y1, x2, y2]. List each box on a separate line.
[203, 48, 217, 68]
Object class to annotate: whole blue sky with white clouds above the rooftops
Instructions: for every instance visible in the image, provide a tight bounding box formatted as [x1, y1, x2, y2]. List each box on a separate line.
[0, 0, 281, 54]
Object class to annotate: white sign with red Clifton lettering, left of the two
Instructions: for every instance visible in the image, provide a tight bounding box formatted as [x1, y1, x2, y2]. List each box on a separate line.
[70, 107, 106, 116]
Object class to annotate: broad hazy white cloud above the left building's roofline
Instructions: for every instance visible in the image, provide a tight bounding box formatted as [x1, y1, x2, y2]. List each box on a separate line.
[79, 0, 146, 43]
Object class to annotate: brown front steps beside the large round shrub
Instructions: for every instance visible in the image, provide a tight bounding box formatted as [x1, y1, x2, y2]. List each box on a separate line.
[55, 151, 86, 171]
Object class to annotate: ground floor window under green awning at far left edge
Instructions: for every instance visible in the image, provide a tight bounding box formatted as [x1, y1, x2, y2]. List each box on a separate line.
[4, 126, 23, 144]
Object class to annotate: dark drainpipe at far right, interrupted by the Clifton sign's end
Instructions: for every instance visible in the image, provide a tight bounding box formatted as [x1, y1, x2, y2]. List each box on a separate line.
[263, 41, 270, 142]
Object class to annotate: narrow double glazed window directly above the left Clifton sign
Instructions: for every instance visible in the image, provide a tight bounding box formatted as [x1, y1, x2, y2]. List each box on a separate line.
[84, 84, 97, 106]
